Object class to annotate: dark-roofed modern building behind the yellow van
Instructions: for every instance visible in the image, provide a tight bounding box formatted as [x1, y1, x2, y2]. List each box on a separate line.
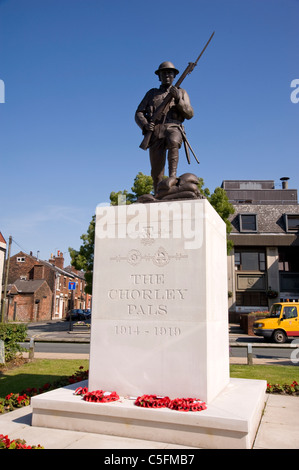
[226, 178, 299, 319]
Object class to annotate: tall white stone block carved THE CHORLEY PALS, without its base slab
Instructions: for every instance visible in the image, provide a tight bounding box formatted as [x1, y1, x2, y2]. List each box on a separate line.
[88, 199, 229, 403]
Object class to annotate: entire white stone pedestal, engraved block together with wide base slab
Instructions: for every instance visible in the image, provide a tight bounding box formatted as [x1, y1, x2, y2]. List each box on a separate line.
[31, 200, 266, 449]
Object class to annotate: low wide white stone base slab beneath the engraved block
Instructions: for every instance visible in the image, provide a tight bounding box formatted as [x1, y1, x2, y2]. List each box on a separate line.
[31, 379, 267, 449]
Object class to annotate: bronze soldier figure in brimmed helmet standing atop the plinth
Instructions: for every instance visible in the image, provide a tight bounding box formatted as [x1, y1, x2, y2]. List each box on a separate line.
[135, 62, 194, 194]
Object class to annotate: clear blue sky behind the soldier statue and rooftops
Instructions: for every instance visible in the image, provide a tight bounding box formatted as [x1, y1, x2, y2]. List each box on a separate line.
[0, 0, 299, 263]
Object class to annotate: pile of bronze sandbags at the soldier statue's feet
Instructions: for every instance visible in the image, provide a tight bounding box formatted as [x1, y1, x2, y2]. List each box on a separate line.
[137, 173, 204, 203]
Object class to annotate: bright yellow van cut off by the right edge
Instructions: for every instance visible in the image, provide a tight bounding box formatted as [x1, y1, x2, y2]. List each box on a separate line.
[253, 302, 299, 343]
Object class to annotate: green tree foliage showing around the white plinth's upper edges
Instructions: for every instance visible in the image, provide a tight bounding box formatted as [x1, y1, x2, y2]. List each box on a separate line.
[69, 172, 234, 294]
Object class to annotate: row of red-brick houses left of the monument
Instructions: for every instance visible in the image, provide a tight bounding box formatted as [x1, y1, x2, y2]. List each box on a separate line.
[6, 251, 91, 321]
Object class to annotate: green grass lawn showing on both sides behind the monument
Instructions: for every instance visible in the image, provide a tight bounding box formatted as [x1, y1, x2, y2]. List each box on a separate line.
[0, 359, 299, 398]
